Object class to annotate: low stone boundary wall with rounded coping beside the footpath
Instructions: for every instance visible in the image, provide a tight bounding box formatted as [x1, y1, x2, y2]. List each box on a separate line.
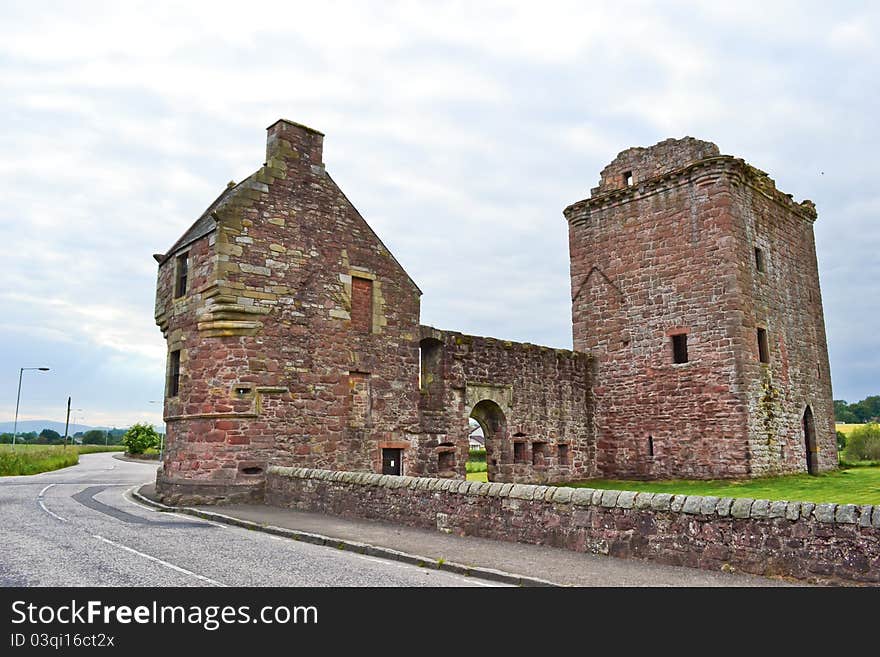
[265, 466, 880, 584]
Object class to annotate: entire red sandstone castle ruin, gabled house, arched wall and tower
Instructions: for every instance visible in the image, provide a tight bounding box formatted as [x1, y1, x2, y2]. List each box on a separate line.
[155, 120, 837, 500]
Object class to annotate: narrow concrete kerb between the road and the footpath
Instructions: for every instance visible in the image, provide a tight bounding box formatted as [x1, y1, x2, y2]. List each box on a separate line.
[131, 489, 562, 587]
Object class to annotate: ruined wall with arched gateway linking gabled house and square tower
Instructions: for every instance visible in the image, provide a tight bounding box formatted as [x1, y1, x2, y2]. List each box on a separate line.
[416, 326, 596, 483]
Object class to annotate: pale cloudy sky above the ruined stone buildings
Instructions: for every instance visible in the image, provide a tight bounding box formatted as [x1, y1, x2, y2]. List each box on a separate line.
[0, 0, 880, 426]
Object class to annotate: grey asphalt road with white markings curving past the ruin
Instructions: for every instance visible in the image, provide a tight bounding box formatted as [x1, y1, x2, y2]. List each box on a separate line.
[0, 453, 495, 586]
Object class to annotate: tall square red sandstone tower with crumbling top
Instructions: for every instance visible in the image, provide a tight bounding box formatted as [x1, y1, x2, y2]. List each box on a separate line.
[565, 137, 837, 478]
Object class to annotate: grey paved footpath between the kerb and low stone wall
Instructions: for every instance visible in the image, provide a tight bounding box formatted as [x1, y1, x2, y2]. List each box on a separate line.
[140, 472, 804, 587]
